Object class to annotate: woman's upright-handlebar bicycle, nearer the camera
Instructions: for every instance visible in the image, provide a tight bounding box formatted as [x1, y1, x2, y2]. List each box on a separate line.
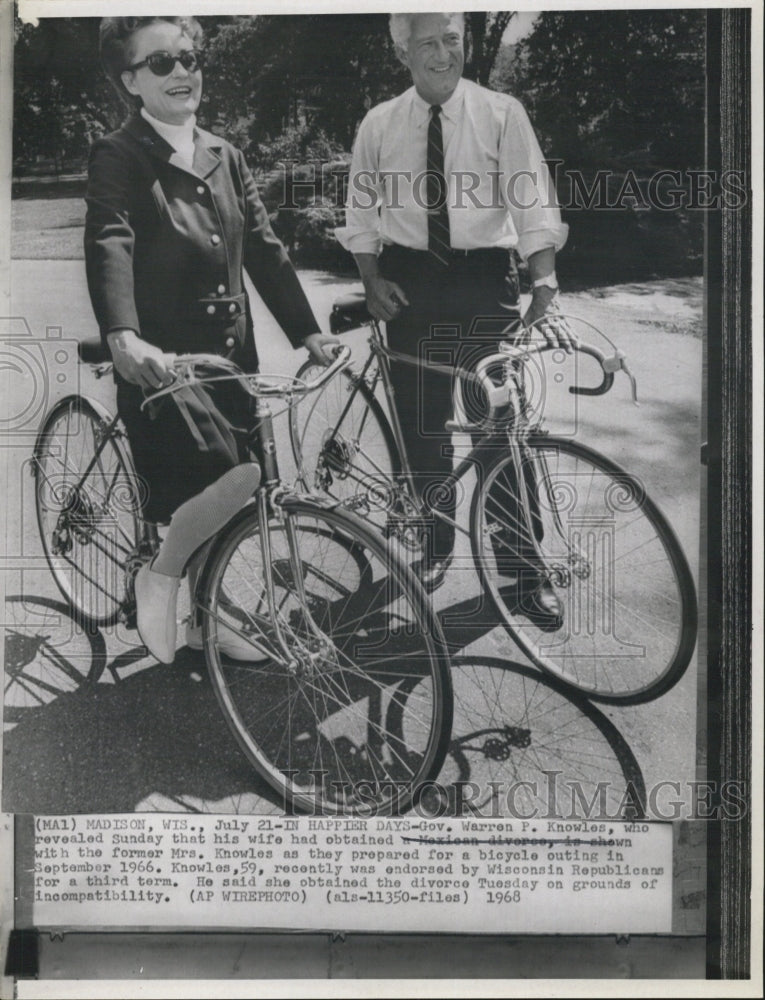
[33, 341, 452, 815]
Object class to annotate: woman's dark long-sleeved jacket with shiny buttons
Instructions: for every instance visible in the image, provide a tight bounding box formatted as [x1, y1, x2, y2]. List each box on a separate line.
[85, 115, 319, 368]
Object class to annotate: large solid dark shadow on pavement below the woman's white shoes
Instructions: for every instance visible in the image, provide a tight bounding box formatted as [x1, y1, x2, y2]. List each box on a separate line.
[3, 649, 273, 813]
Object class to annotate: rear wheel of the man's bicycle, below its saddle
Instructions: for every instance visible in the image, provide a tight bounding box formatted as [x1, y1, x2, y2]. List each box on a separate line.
[289, 360, 402, 529]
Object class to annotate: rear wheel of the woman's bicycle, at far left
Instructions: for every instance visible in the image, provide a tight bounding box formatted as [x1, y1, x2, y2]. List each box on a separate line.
[34, 396, 141, 626]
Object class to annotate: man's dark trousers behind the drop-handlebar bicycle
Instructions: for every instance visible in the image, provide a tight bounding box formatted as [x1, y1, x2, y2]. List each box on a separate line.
[380, 246, 519, 560]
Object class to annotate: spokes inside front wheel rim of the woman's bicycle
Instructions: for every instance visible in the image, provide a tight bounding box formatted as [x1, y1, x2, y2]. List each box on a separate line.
[206, 503, 450, 812]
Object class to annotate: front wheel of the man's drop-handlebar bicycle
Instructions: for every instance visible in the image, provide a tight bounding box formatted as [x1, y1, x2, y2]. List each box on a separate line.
[471, 435, 697, 704]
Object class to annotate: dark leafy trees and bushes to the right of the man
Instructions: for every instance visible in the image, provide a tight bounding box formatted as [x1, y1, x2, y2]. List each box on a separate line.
[498, 9, 705, 283]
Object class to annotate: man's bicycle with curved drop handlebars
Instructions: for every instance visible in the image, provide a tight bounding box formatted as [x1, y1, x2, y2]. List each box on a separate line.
[290, 293, 697, 704]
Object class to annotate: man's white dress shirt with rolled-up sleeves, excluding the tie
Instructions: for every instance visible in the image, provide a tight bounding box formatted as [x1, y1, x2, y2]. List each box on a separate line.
[335, 79, 568, 259]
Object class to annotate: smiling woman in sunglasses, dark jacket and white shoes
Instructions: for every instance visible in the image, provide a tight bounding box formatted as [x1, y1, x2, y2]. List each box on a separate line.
[85, 17, 336, 662]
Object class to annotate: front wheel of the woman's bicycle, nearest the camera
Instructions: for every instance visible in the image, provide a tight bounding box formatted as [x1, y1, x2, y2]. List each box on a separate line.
[199, 497, 452, 815]
